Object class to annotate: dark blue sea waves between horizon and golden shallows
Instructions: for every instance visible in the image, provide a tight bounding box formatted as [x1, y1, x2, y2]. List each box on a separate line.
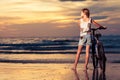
[0, 36, 120, 54]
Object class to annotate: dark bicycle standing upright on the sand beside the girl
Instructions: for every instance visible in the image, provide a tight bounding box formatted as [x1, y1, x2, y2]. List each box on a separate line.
[91, 28, 106, 72]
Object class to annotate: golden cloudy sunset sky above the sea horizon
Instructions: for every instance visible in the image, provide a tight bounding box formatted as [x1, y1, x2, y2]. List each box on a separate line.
[0, 0, 120, 37]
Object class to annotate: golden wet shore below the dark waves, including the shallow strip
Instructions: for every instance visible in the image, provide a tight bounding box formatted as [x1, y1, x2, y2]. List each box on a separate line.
[0, 54, 120, 80]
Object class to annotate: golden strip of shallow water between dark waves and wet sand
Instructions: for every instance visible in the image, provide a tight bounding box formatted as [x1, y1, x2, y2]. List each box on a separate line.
[0, 54, 120, 64]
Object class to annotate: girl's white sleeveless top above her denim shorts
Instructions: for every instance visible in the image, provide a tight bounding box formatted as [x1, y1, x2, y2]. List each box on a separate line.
[80, 18, 92, 36]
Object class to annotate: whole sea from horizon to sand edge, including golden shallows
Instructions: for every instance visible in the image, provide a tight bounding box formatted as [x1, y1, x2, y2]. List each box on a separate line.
[0, 35, 120, 63]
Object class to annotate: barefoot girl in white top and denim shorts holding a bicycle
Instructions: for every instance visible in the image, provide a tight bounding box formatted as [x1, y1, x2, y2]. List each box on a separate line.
[72, 8, 104, 70]
